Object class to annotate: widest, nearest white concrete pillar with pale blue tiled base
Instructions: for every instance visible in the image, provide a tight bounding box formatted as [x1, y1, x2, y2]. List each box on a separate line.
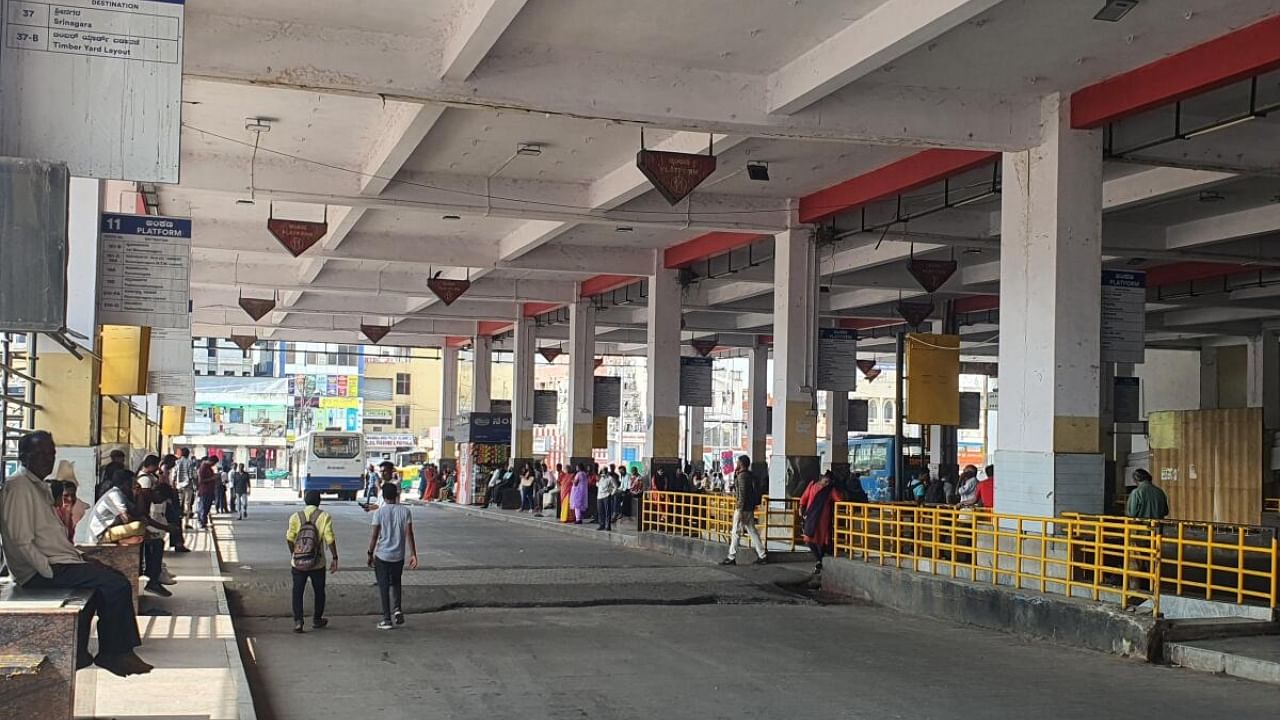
[996, 95, 1105, 515]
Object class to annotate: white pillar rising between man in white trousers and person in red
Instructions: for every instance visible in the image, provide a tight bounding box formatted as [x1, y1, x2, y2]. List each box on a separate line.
[769, 228, 818, 497]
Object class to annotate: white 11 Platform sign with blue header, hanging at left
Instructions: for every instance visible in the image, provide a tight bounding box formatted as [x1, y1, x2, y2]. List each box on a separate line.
[97, 213, 191, 328]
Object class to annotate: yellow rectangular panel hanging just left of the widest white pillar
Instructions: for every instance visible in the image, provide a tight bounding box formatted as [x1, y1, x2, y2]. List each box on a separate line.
[906, 333, 960, 425]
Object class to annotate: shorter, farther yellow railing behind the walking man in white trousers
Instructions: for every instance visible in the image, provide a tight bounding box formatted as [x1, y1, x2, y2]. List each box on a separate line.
[641, 491, 801, 551]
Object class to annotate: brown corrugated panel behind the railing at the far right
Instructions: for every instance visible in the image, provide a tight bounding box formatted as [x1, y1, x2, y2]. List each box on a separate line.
[1147, 407, 1266, 525]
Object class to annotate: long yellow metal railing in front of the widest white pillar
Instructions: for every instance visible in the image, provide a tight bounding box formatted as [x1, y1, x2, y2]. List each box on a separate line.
[835, 502, 1160, 614]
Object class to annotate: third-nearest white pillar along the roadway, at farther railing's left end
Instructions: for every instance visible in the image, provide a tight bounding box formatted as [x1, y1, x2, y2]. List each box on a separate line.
[645, 268, 681, 475]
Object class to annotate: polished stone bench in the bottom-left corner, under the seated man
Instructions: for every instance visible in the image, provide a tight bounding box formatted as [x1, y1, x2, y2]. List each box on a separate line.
[0, 583, 90, 720]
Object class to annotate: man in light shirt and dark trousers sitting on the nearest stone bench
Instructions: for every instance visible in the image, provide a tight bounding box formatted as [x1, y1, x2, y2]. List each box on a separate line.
[0, 430, 151, 676]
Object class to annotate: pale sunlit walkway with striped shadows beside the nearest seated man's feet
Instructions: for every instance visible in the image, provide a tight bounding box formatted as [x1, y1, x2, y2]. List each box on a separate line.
[76, 520, 257, 720]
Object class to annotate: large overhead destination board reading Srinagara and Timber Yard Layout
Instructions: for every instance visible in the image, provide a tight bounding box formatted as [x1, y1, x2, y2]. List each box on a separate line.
[0, 0, 186, 183]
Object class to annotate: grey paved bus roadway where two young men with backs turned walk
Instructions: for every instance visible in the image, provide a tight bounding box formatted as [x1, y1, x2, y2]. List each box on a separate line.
[221, 497, 1275, 720]
